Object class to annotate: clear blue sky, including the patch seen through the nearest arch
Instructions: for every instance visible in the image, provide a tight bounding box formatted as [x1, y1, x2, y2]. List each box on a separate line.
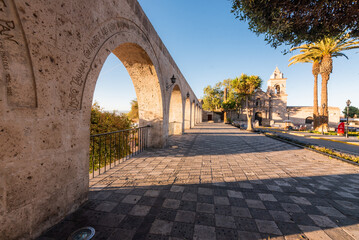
[94, 0, 359, 111]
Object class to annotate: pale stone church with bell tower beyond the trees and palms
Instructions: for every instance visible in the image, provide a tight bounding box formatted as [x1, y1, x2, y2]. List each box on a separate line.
[203, 67, 340, 129]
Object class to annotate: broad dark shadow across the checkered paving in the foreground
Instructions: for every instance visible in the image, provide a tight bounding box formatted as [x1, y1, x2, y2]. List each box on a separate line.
[39, 174, 359, 239]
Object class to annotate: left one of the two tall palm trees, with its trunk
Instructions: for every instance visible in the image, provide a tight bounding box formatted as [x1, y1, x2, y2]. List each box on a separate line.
[288, 44, 321, 129]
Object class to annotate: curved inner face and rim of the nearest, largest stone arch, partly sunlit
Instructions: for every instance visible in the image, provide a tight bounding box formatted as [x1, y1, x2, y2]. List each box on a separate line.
[82, 41, 164, 147]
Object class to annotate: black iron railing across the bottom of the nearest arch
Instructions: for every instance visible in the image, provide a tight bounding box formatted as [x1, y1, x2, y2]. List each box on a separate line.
[89, 126, 149, 177]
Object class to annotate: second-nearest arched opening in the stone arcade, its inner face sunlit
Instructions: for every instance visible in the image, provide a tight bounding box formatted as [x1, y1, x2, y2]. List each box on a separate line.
[168, 85, 183, 135]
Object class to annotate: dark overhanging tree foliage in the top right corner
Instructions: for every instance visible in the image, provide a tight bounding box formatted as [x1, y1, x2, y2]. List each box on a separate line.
[232, 0, 359, 47]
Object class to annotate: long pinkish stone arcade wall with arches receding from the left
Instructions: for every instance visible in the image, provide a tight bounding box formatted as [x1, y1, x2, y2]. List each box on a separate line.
[0, 0, 201, 239]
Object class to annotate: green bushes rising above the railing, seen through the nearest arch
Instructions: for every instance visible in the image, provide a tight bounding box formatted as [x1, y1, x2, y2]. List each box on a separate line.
[90, 102, 131, 135]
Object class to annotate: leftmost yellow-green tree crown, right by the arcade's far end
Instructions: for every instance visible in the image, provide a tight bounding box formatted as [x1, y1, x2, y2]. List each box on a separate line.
[202, 83, 223, 112]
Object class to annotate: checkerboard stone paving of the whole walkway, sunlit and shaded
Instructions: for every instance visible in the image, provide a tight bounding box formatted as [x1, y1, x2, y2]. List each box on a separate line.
[39, 124, 359, 240]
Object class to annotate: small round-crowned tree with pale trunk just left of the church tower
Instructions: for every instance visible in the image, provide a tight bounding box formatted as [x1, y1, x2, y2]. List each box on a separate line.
[232, 74, 262, 131]
